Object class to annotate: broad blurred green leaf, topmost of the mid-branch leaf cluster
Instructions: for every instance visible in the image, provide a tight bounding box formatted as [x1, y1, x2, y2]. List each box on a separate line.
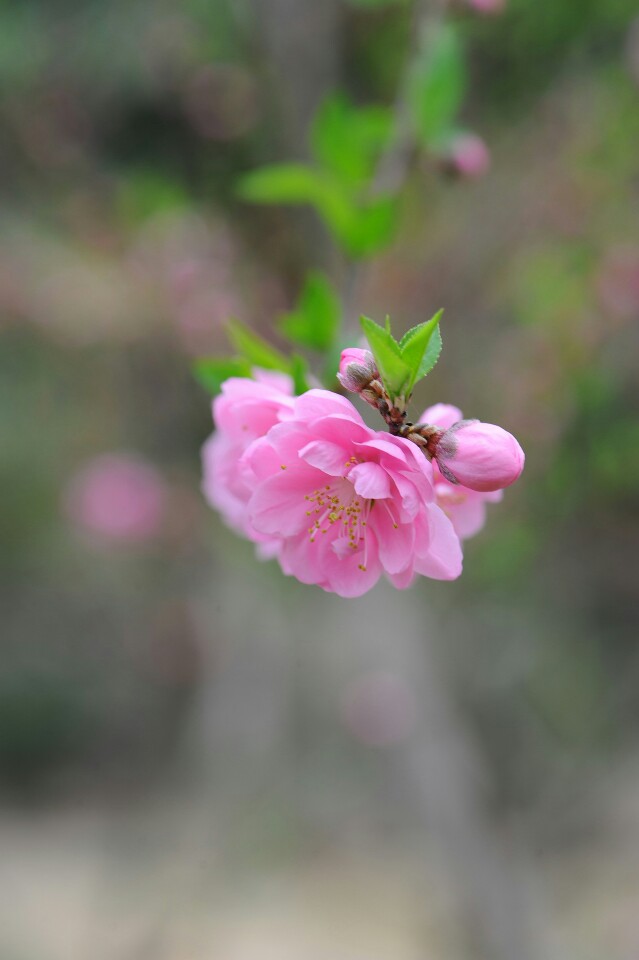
[311, 93, 392, 188]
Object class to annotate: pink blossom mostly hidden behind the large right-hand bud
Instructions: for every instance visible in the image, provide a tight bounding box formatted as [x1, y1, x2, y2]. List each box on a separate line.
[419, 403, 503, 540]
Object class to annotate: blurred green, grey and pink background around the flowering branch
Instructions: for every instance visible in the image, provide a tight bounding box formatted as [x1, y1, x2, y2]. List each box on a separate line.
[0, 0, 639, 960]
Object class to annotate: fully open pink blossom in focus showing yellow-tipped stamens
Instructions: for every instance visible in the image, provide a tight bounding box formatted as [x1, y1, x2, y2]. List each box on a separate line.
[241, 390, 462, 597]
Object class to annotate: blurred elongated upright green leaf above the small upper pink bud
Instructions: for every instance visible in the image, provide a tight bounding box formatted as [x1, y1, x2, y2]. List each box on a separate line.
[410, 23, 466, 146]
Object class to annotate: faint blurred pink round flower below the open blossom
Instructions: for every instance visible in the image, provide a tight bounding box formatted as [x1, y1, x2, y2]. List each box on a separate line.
[340, 672, 416, 747]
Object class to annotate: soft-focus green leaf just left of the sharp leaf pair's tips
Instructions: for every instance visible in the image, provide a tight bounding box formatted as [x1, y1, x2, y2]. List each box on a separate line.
[278, 272, 341, 351]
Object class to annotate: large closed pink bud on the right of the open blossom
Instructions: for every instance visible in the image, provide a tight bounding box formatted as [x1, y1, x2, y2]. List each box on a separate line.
[435, 420, 525, 492]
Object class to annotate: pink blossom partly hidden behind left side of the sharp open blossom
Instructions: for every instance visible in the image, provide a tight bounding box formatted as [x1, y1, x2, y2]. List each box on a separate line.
[202, 370, 293, 556]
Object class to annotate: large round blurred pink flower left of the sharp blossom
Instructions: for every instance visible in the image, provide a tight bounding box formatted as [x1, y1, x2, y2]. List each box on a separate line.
[64, 453, 167, 542]
